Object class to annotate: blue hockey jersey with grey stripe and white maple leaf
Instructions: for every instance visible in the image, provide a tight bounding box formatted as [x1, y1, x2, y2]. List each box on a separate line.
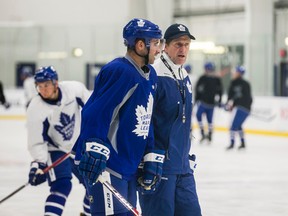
[73, 56, 157, 180]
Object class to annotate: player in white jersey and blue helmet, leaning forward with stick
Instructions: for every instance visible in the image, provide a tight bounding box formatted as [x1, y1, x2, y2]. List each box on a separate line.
[27, 66, 90, 216]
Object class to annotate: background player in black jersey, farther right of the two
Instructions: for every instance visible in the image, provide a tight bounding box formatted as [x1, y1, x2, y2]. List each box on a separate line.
[225, 66, 253, 150]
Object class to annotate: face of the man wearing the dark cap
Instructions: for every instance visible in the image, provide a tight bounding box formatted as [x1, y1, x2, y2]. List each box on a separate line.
[165, 35, 191, 65]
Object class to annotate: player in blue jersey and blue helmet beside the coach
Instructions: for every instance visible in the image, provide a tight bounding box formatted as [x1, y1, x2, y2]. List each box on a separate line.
[73, 18, 164, 216]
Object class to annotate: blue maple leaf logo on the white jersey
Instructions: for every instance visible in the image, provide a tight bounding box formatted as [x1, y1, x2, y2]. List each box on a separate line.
[54, 113, 75, 140]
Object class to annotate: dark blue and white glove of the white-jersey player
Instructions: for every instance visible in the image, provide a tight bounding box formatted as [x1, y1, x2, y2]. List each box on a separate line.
[29, 161, 47, 186]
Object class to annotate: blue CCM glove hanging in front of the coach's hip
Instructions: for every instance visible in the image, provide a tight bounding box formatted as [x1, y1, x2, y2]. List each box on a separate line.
[138, 150, 165, 194]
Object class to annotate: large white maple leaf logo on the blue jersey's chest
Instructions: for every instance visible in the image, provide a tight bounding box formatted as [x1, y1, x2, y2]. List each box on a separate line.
[132, 93, 154, 139]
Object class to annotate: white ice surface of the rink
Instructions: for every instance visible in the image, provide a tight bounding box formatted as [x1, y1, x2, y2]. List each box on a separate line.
[0, 114, 288, 216]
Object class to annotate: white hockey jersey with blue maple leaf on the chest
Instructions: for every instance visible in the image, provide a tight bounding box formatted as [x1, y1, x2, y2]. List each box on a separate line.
[27, 81, 90, 163]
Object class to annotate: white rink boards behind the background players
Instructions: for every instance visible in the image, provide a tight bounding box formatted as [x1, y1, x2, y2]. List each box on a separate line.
[0, 89, 288, 134]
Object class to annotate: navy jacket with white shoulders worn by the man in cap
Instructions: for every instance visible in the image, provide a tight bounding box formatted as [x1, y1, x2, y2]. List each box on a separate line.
[153, 53, 192, 174]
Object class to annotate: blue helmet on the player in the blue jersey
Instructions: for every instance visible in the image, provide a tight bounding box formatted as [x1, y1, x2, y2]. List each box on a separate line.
[123, 18, 162, 47]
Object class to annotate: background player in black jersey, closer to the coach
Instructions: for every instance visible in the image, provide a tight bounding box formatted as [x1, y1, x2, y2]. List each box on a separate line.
[195, 62, 223, 143]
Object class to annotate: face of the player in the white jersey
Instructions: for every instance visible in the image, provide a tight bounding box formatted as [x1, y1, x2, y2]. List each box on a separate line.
[36, 81, 58, 100]
